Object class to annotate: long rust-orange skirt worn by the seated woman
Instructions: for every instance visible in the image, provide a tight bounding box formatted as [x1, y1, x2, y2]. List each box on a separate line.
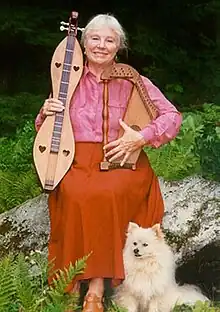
[49, 143, 164, 289]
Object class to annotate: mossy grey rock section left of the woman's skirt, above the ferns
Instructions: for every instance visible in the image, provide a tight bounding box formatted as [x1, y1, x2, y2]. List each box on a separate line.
[0, 194, 49, 257]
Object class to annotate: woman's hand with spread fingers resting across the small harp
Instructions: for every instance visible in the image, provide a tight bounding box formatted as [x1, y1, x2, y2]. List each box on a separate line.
[103, 119, 146, 166]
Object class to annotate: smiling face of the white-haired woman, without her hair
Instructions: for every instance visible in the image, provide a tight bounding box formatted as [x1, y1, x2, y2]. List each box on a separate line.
[84, 27, 119, 65]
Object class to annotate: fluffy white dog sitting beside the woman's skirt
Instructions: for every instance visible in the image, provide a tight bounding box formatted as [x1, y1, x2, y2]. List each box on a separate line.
[114, 222, 209, 312]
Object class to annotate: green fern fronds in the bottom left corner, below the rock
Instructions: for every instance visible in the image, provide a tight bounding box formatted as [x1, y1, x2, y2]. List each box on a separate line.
[0, 252, 88, 312]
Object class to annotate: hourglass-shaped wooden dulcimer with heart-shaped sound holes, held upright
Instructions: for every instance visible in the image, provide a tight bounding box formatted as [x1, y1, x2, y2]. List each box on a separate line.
[33, 12, 83, 191]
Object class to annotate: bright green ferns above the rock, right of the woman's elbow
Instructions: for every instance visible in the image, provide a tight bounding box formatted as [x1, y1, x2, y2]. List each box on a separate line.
[145, 104, 220, 181]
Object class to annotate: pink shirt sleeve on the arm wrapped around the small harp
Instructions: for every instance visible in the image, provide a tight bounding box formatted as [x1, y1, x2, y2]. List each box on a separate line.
[140, 76, 182, 148]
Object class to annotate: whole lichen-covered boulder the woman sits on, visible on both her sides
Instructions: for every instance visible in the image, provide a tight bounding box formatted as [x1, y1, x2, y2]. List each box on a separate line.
[0, 177, 220, 300]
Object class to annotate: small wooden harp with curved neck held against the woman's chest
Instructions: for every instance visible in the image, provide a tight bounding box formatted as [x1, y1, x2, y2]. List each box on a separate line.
[100, 63, 158, 170]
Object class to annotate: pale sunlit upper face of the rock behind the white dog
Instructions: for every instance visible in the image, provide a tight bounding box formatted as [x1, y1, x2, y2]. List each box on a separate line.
[160, 177, 220, 264]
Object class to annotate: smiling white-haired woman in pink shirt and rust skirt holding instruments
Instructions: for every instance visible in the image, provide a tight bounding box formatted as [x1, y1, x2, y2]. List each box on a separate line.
[36, 14, 182, 312]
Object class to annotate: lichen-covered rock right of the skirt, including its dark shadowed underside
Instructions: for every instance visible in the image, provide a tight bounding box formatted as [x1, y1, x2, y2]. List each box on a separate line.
[160, 177, 220, 301]
